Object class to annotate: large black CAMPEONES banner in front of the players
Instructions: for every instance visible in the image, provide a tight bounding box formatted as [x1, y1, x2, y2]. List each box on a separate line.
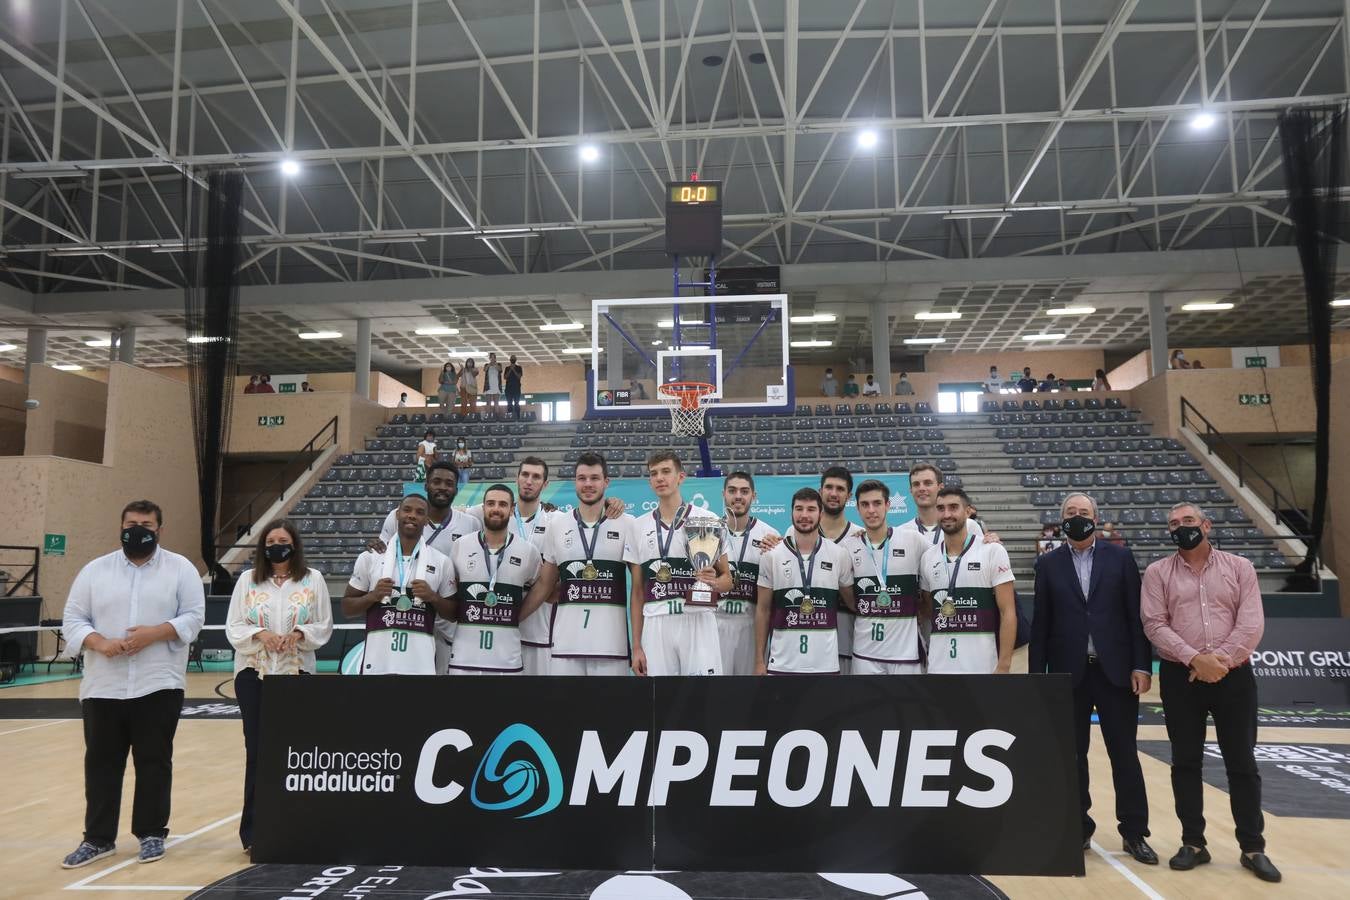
[252, 676, 1083, 876]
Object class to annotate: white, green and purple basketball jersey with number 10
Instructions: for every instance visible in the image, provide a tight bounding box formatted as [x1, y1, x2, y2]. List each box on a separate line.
[450, 532, 540, 672]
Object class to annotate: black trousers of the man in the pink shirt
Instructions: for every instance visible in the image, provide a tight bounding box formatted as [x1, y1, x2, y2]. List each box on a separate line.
[1158, 660, 1265, 853]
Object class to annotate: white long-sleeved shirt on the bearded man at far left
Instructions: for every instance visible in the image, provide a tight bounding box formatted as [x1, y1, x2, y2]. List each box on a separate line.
[61, 546, 207, 700]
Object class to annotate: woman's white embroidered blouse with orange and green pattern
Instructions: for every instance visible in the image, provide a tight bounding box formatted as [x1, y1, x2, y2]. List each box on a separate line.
[225, 568, 333, 675]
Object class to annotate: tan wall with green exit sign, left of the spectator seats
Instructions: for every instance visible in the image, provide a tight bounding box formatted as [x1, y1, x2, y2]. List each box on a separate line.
[230, 391, 389, 453]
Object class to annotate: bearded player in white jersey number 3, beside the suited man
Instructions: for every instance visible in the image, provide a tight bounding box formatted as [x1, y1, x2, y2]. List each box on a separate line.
[919, 487, 1017, 675]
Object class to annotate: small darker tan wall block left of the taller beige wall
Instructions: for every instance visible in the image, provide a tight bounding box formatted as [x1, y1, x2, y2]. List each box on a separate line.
[23, 366, 107, 463]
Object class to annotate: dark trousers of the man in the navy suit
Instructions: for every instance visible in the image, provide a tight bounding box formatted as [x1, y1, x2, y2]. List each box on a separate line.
[1073, 663, 1149, 841]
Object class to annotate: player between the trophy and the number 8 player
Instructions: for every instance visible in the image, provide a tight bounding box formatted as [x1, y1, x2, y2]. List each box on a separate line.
[713, 472, 779, 675]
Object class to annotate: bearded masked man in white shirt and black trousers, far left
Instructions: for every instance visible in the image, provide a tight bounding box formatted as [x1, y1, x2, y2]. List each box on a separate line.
[61, 501, 207, 869]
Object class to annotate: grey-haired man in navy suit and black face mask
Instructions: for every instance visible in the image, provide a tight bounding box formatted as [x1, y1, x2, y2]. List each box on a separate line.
[1029, 494, 1158, 865]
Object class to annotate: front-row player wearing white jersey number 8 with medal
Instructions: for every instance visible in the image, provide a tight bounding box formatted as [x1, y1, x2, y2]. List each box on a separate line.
[755, 487, 855, 675]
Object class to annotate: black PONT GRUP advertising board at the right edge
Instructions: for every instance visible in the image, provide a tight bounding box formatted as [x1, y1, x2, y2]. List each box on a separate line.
[1251, 618, 1350, 706]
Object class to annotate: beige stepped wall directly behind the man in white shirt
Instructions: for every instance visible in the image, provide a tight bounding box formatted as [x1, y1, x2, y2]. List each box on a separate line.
[0, 364, 201, 626]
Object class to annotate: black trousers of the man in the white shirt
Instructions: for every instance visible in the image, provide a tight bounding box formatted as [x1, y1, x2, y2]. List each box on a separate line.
[80, 691, 182, 845]
